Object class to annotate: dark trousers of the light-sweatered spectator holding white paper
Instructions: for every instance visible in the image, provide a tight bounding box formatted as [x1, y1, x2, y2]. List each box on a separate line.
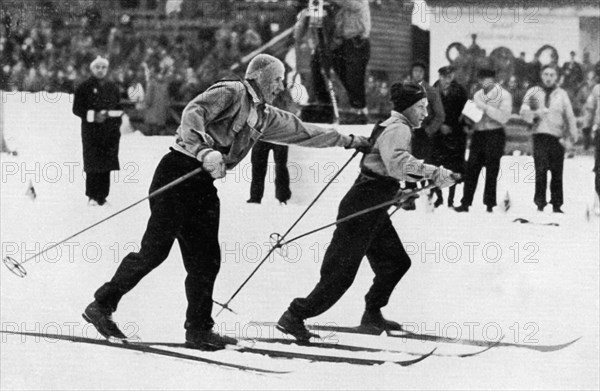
[461, 128, 506, 207]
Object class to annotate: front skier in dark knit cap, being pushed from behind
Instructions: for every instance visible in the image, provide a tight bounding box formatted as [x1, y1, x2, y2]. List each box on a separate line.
[278, 83, 459, 341]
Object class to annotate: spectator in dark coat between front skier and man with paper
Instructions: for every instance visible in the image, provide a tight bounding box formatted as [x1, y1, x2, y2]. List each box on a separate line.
[432, 66, 468, 207]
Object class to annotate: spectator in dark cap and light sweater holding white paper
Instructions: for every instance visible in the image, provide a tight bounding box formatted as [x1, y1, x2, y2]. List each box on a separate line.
[454, 69, 512, 212]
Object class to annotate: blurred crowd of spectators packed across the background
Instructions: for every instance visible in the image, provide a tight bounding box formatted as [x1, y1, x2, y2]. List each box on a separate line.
[0, 0, 599, 145]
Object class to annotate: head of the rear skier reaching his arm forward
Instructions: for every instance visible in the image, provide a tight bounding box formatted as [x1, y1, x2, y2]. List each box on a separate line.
[245, 54, 285, 103]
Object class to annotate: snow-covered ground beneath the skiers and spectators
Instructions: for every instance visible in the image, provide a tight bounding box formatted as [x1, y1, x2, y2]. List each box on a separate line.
[0, 93, 600, 389]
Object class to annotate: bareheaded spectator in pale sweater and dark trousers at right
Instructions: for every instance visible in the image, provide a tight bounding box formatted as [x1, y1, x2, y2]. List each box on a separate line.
[520, 65, 577, 213]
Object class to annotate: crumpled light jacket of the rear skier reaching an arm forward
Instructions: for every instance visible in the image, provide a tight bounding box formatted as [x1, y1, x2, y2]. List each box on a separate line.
[173, 81, 352, 170]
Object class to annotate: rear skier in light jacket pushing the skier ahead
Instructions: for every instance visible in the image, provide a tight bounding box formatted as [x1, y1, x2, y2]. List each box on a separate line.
[84, 54, 370, 350]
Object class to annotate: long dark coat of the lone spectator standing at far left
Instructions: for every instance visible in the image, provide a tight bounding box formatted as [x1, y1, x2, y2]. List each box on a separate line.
[73, 77, 122, 173]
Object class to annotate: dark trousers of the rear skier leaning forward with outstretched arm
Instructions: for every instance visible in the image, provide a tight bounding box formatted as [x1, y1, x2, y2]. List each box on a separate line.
[95, 151, 221, 330]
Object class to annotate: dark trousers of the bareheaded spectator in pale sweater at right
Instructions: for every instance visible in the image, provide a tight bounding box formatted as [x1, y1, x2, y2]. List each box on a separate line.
[533, 133, 565, 207]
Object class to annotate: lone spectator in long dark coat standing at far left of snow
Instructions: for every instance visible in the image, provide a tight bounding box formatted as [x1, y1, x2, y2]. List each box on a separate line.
[73, 56, 122, 206]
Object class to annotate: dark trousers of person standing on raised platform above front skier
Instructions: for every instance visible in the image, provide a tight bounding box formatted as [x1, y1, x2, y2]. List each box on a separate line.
[311, 37, 371, 109]
